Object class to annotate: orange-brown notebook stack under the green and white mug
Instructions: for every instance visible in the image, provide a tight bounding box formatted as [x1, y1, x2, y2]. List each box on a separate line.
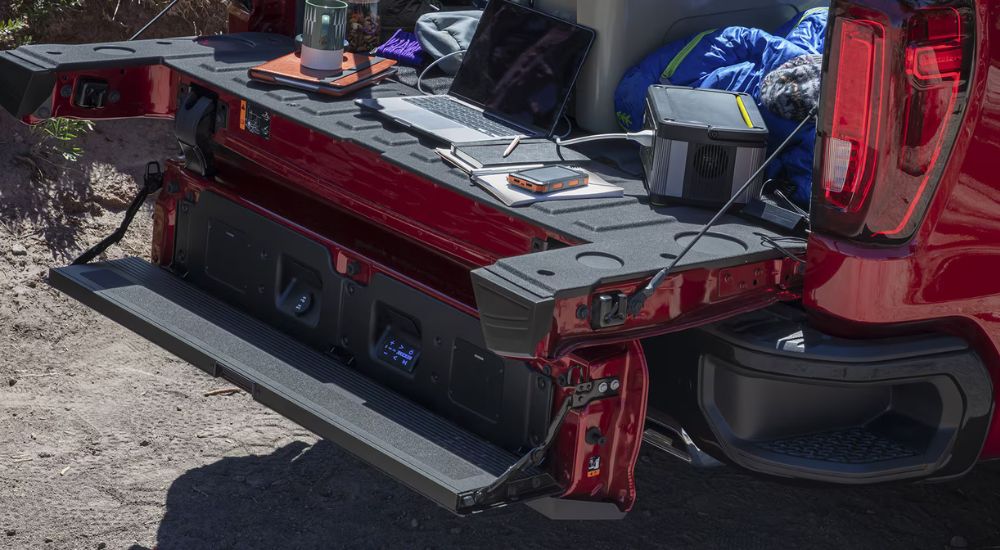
[247, 52, 396, 97]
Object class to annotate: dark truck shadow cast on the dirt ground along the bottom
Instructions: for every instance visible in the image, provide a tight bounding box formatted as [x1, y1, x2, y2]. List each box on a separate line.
[146, 442, 1000, 550]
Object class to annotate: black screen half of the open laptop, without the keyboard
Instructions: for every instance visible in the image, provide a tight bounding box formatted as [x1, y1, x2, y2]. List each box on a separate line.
[449, 0, 594, 135]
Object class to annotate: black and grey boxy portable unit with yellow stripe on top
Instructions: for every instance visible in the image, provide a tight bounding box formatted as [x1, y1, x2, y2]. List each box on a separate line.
[641, 86, 767, 206]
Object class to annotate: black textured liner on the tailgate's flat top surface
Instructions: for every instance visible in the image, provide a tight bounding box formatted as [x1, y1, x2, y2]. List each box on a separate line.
[0, 33, 794, 312]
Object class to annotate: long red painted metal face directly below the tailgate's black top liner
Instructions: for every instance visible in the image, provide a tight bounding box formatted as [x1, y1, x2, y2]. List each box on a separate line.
[207, 94, 573, 266]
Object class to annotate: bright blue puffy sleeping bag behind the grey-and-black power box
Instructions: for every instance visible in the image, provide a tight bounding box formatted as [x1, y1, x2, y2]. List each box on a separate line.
[615, 8, 827, 205]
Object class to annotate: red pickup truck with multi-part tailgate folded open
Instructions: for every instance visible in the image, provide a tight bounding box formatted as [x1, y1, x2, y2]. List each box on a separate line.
[0, 0, 1000, 518]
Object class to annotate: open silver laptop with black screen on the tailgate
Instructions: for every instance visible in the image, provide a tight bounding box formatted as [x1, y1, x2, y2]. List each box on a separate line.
[357, 0, 595, 143]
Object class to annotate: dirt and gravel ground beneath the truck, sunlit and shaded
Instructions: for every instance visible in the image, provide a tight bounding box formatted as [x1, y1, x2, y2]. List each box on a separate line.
[0, 114, 1000, 550]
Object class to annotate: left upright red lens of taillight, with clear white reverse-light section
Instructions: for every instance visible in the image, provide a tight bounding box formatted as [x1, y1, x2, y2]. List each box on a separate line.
[822, 20, 885, 212]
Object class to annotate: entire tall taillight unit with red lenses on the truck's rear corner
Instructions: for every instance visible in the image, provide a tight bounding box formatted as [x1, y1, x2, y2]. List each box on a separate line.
[812, 2, 971, 243]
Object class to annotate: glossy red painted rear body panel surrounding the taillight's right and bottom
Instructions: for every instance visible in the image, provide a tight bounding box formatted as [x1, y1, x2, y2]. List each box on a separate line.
[803, 2, 1000, 458]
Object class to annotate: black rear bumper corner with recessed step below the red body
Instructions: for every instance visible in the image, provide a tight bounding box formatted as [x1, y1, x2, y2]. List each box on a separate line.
[646, 306, 994, 484]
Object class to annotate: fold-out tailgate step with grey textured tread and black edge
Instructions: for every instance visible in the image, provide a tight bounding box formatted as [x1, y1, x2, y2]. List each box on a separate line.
[50, 258, 558, 514]
